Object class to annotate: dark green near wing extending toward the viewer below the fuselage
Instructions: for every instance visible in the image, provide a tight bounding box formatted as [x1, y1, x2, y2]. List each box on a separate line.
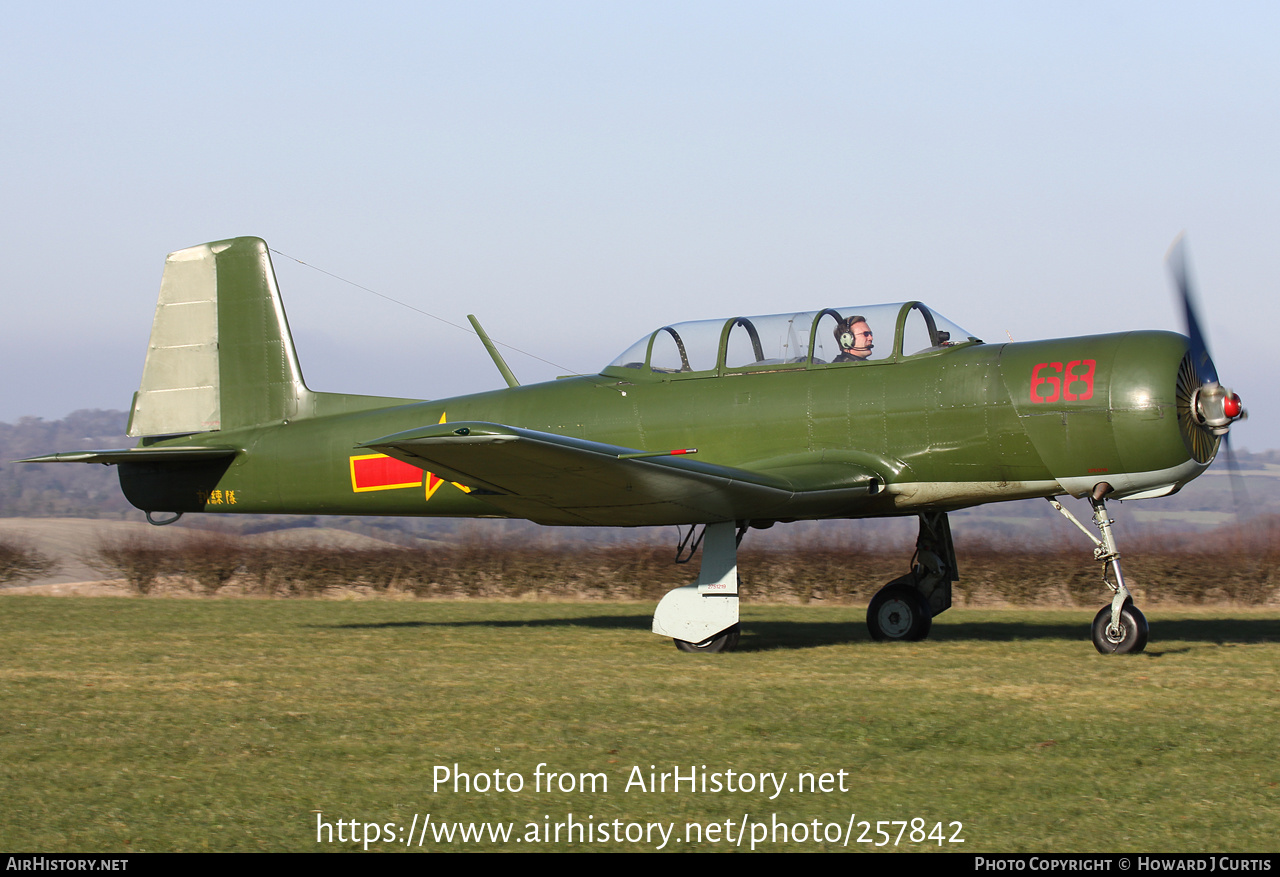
[360, 422, 884, 526]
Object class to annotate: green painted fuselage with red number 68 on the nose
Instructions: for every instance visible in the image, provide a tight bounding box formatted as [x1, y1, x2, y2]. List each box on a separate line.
[119, 325, 1198, 525]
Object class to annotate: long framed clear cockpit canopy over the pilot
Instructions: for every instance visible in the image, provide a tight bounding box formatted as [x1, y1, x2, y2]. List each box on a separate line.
[604, 301, 982, 376]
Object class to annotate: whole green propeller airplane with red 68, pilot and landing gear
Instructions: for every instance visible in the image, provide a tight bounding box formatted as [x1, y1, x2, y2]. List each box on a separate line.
[27, 238, 1244, 653]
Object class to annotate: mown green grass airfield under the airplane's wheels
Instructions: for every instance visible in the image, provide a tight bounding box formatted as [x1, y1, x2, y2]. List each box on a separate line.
[0, 597, 1280, 853]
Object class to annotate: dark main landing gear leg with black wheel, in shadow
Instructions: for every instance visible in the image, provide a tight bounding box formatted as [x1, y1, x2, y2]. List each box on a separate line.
[867, 512, 959, 641]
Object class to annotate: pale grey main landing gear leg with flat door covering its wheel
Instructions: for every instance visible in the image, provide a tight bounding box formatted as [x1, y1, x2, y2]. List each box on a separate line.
[653, 521, 746, 652]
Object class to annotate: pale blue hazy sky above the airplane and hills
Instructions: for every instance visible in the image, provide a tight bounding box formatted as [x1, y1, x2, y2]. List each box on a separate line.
[0, 0, 1280, 451]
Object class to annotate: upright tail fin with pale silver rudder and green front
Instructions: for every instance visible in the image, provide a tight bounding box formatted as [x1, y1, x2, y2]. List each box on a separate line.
[128, 237, 311, 437]
